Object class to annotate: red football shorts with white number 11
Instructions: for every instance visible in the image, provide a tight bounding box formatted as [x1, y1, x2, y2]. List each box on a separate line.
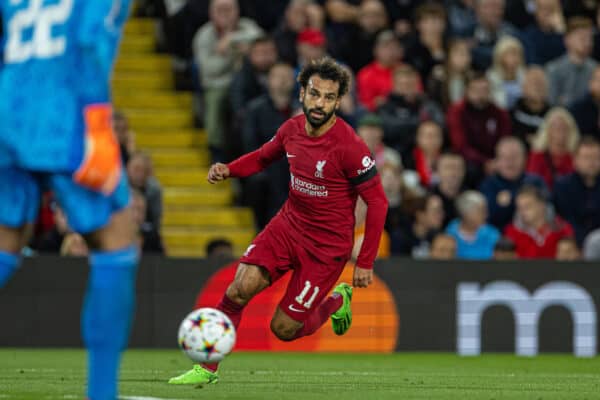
[240, 215, 347, 322]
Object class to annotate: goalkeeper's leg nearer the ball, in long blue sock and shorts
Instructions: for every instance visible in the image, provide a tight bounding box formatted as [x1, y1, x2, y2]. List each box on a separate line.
[49, 175, 139, 400]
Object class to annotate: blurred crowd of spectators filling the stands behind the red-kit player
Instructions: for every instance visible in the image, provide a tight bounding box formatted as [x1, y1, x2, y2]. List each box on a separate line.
[34, 0, 600, 260]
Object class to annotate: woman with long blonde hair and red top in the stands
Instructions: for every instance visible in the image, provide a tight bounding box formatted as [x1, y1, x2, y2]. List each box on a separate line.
[527, 107, 579, 190]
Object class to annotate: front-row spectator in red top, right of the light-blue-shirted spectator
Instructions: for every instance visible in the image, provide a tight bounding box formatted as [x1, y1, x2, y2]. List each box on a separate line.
[504, 186, 574, 259]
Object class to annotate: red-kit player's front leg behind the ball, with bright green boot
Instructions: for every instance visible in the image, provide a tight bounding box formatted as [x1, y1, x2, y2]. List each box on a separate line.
[169, 263, 271, 385]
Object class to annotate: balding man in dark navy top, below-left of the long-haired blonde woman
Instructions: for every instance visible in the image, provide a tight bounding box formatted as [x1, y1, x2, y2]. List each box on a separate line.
[479, 136, 546, 230]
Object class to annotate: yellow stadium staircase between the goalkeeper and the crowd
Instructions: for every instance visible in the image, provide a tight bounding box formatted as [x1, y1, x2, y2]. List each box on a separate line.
[112, 18, 255, 257]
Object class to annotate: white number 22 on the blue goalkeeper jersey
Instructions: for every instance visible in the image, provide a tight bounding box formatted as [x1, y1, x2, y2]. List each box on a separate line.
[4, 0, 73, 64]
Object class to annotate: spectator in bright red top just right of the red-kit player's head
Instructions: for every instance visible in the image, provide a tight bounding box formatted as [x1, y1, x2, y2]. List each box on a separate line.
[356, 30, 403, 111]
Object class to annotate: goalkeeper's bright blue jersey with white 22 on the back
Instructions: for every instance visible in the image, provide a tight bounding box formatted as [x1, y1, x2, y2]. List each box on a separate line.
[0, 0, 130, 172]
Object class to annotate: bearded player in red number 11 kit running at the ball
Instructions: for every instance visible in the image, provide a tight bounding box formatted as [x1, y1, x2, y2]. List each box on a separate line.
[169, 58, 387, 384]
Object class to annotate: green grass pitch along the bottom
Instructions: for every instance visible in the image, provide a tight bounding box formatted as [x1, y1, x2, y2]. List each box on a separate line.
[0, 349, 600, 400]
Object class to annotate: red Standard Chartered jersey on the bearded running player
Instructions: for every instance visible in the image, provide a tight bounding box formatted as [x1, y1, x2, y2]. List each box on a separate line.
[230, 114, 380, 257]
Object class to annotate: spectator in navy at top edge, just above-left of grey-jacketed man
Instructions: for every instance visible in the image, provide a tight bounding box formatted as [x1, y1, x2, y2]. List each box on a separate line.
[521, 0, 566, 65]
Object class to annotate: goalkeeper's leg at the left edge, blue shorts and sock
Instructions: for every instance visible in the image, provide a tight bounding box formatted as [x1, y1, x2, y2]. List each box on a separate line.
[0, 167, 40, 288]
